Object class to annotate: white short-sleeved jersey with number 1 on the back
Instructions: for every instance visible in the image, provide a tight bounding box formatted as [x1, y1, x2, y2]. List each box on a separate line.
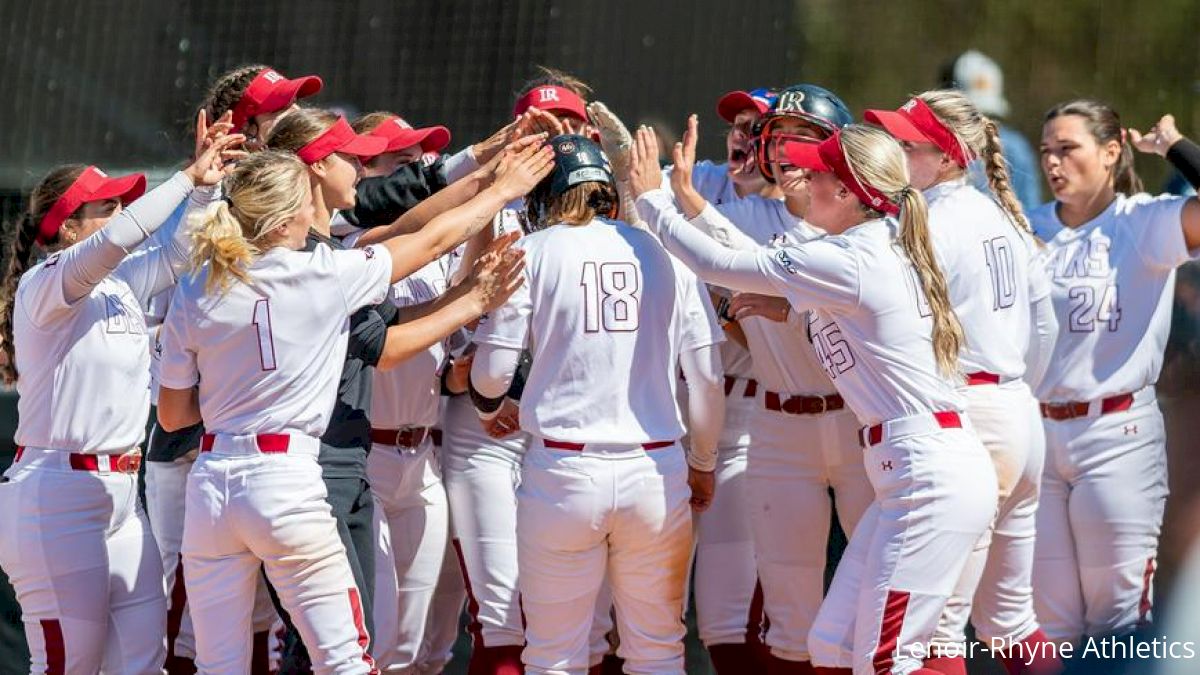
[160, 241, 391, 437]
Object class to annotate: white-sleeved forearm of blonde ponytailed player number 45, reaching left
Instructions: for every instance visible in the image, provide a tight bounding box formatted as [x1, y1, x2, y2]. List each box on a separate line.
[637, 190, 779, 295]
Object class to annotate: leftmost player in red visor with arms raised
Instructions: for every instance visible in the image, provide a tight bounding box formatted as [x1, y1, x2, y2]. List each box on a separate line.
[0, 115, 242, 674]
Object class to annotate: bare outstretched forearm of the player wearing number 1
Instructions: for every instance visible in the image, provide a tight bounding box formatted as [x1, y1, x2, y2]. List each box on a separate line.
[383, 181, 508, 283]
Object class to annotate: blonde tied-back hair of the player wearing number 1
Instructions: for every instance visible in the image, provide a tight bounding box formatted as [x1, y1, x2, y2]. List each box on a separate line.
[192, 151, 308, 294]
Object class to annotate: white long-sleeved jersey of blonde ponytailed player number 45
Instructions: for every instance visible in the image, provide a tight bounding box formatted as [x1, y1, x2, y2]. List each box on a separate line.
[637, 190, 965, 425]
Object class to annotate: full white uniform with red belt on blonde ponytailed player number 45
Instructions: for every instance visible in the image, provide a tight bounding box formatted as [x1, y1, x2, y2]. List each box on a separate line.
[637, 190, 996, 674]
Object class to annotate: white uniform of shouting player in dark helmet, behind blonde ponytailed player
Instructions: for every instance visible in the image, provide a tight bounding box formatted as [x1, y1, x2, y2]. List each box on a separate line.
[691, 198, 875, 662]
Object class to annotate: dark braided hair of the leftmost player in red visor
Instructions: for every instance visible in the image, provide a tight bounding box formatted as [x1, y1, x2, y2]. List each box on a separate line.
[0, 165, 85, 384]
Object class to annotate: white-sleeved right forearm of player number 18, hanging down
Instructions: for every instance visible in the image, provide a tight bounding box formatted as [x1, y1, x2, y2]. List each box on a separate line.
[679, 345, 725, 471]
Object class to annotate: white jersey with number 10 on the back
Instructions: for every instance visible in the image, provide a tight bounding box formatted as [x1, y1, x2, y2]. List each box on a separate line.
[925, 178, 1050, 381]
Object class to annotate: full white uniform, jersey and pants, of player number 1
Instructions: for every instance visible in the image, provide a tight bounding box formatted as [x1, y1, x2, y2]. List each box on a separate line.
[160, 240, 391, 674]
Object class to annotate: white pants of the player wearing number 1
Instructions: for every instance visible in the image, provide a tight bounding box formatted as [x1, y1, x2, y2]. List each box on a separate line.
[182, 435, 373, 675]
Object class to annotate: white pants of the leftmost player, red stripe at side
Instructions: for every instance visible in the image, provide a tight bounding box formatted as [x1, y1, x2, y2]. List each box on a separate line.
[0, 448, 169, 675]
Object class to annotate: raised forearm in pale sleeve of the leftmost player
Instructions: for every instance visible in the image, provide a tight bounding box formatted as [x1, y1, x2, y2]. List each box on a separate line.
[59, 172, 193, 303]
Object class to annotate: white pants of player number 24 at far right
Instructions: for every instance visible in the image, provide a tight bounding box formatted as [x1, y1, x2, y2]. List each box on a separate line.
[1033, 387, 1168, 643]
